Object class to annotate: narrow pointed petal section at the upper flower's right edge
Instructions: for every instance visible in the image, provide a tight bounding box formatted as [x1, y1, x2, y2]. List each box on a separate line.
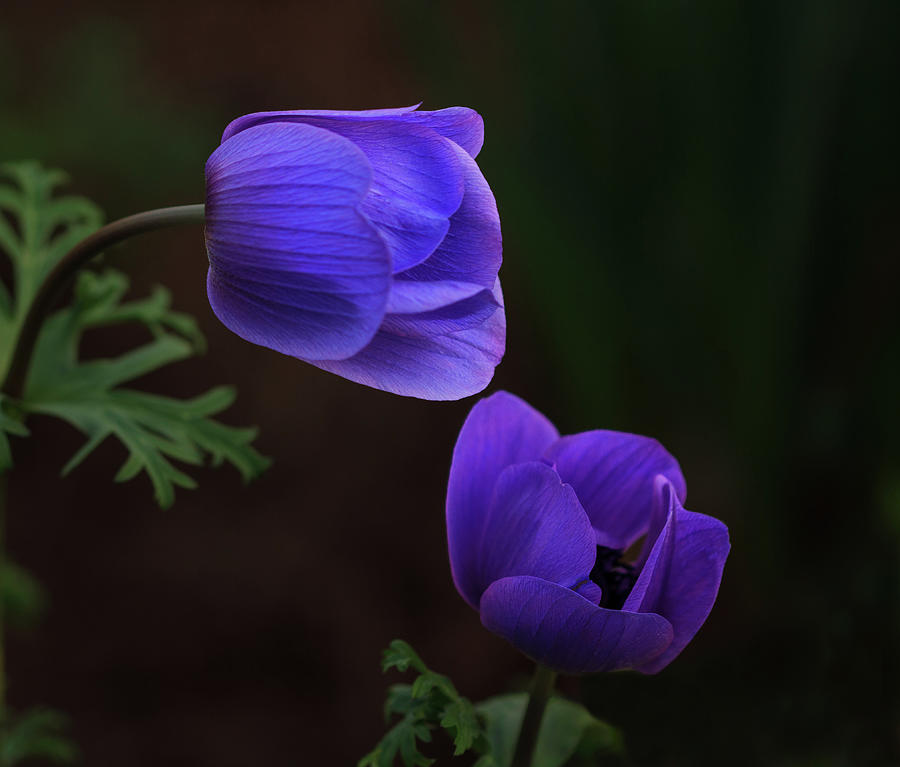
[395, 140, 503, 288]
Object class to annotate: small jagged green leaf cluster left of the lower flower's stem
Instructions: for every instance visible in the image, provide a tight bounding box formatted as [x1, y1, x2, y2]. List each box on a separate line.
[357, 639, 495, 767]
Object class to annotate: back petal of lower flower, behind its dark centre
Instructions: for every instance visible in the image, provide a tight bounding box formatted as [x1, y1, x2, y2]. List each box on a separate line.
[546, 431, 687, 549]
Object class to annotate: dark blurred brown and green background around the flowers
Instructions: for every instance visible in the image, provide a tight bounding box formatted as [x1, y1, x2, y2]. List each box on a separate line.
[0, 0, 900, 767]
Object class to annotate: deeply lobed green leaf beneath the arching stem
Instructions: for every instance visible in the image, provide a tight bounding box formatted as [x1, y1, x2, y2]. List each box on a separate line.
[21, 271, 268, 508]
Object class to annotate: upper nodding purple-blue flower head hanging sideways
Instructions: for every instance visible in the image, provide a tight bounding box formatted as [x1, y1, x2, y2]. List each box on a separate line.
[206, 107, 506, 400]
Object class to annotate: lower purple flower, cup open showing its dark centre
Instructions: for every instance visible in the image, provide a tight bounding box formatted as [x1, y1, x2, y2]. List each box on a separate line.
[447, 392, 729, 674]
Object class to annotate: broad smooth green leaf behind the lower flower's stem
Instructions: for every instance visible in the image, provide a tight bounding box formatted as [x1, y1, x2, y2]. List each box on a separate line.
[475, 693, 624, 767]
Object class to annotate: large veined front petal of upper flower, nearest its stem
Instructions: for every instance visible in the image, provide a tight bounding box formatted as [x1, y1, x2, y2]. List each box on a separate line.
[206, 124, 391, 358]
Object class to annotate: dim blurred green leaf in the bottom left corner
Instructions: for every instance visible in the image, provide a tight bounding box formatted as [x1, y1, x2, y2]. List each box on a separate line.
[0, 708, 78, 767]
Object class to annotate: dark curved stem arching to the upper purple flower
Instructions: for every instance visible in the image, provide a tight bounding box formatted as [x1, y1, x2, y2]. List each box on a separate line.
[0, 204, 204, 398]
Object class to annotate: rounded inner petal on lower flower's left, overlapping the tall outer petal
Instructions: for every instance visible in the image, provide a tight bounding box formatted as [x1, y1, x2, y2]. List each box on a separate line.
[465, 461, 597, 608]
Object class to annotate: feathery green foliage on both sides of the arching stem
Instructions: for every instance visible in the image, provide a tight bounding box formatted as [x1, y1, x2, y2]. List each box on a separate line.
[0, 163, 268, 507]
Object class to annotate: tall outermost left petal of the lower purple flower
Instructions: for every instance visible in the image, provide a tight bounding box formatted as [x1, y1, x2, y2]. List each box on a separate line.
[447, 391, 559, 609]
